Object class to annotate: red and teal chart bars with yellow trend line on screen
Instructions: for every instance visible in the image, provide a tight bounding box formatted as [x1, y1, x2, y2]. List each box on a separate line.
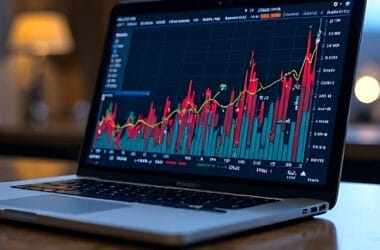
[93, 29, 321, 162]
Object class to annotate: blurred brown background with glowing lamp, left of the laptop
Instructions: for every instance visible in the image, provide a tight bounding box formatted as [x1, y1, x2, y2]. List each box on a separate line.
[0, 0, 117, 159]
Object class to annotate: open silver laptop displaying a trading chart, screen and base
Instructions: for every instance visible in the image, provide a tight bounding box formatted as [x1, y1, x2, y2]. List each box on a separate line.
[0, 0, 365, 246]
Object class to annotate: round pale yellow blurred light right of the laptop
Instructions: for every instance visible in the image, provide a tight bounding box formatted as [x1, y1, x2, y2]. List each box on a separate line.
[354, 76, 380, 104]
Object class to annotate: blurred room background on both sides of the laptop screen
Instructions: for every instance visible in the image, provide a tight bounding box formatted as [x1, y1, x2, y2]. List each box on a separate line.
[0, 0, 380, 181]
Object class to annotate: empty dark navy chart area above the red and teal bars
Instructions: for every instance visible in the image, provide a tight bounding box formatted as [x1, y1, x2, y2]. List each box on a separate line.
[118, 19, 320, 119]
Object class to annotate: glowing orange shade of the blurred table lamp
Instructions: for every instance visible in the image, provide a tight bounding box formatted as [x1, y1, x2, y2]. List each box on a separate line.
[8, 11, 74, 56]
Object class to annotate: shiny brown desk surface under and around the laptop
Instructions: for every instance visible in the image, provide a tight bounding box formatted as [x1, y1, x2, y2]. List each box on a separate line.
[0, 157, 380, 250]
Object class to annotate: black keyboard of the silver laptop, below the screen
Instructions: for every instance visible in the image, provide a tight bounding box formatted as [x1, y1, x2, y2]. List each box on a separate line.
[14, 179, 278, 212]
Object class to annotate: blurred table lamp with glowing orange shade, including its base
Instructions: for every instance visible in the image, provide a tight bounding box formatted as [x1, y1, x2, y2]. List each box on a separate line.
[7, 11, 74, 121]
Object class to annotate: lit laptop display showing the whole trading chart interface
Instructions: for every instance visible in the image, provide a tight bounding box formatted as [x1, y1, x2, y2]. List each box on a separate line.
[86, 0, 352, 185]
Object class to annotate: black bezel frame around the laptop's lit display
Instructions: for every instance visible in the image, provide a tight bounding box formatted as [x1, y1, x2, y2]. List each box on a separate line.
[77, 0, 365, 208]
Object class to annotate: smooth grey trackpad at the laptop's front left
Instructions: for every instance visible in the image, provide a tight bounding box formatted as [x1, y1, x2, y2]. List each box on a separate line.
[0, 195, 128, 214]
